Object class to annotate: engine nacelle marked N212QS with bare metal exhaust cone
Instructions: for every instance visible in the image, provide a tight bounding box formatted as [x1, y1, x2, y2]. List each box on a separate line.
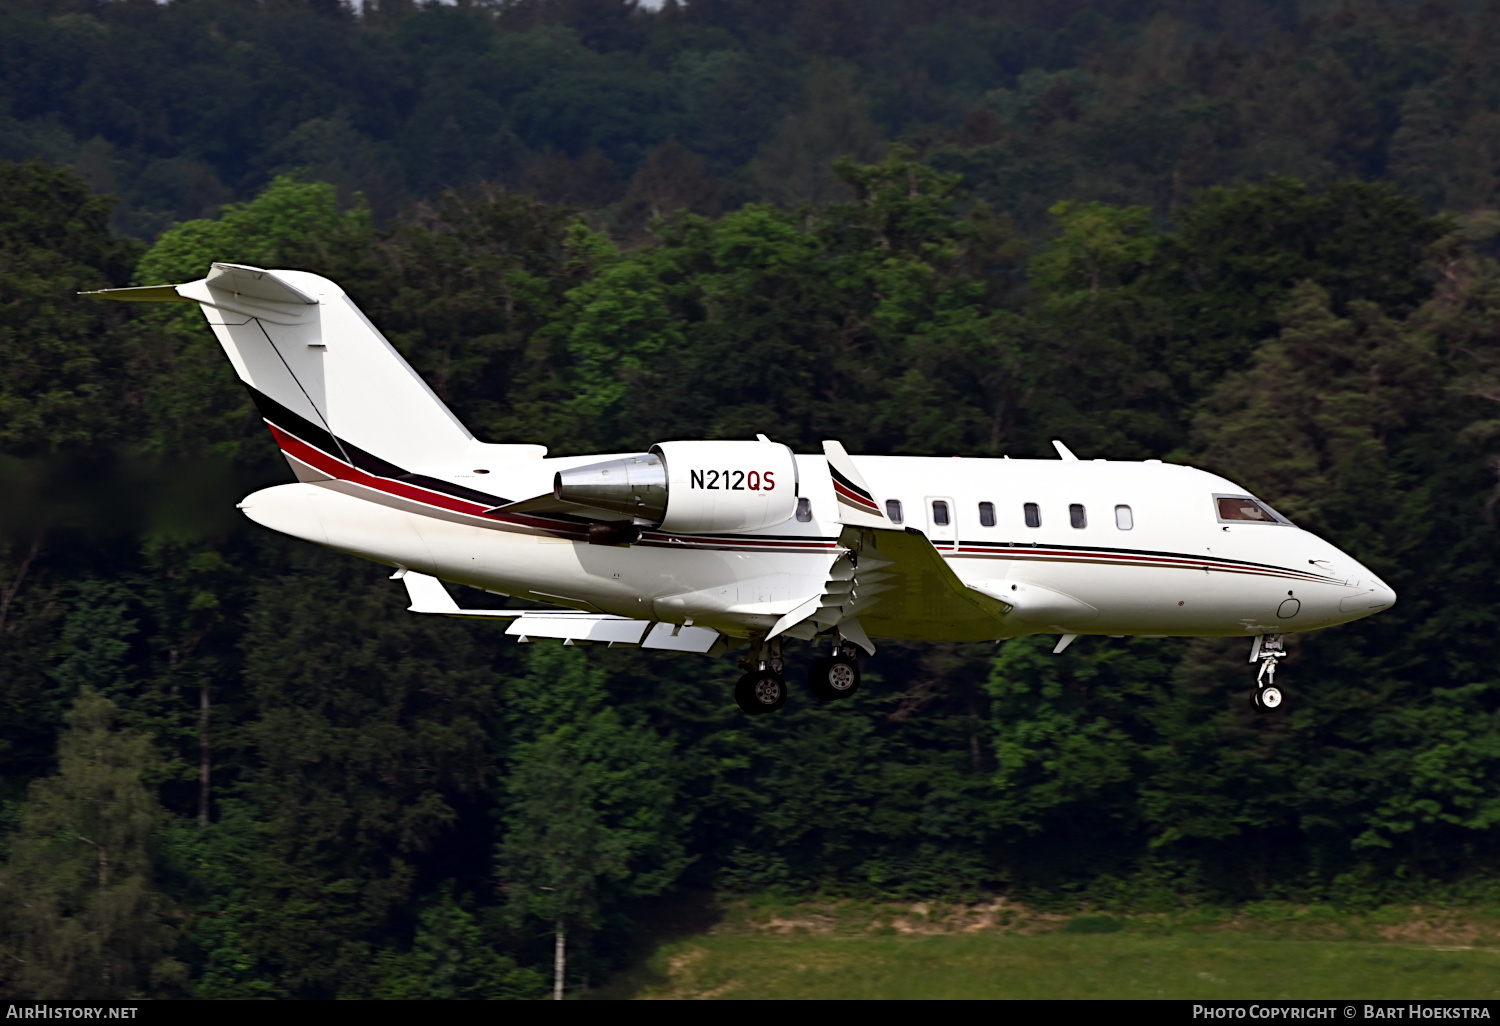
[552, 441, 797, 534]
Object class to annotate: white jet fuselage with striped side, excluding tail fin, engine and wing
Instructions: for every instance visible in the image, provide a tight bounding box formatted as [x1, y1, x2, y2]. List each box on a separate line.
[243, 447, 1395, 641]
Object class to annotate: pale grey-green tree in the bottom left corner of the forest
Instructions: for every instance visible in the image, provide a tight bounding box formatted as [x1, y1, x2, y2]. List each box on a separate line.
[0, 687, 180, 999]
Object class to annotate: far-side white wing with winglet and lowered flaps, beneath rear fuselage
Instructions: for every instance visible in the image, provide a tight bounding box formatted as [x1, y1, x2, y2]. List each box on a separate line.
[393, 570, 720, 654]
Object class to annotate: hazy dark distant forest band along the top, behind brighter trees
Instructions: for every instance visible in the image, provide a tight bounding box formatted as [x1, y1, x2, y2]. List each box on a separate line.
[0, 0, 1500, 237]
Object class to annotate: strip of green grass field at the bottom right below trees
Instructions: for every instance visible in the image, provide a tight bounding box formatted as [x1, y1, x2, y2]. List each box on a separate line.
[599, 900, 1500, 999]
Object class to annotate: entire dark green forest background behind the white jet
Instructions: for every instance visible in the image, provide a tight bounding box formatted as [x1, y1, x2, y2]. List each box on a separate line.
[0, 0, 1500, 998]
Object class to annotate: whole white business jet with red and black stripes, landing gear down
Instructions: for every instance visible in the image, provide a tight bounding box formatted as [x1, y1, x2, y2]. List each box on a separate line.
[89, 264, 1395, 714]
